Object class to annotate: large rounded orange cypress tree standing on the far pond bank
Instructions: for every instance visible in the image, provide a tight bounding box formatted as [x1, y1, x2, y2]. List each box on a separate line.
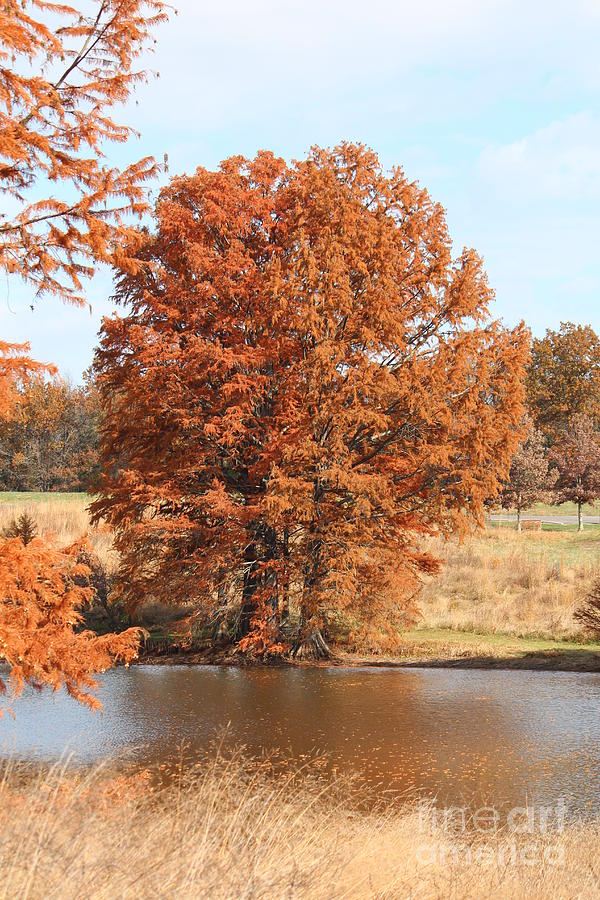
[94, 144, 528, 655]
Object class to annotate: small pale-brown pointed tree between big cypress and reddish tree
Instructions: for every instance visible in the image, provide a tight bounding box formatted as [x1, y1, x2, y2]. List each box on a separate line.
[500, 416, 558, 531]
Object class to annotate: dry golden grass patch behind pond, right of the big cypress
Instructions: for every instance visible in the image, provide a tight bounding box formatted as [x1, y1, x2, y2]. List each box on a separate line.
[420, 528, 600, 639]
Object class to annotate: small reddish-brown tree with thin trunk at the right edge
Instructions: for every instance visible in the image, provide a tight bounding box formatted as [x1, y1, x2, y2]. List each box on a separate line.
[551, 413, 600, 531]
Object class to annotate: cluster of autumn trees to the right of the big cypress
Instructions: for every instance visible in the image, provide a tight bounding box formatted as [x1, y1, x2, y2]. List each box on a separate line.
[500, 322, 600, 530]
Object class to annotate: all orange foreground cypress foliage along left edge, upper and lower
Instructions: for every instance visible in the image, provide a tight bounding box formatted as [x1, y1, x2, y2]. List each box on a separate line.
[0, 0, 166, 703]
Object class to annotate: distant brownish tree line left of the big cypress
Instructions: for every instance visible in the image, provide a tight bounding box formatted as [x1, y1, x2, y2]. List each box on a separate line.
[0, 377, 98, 491]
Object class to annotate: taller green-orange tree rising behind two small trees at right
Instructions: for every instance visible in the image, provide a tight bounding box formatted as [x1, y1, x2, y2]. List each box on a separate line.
[526, 322, 600, 441]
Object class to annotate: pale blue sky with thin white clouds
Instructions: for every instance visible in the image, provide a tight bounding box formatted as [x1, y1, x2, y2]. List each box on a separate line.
[0, 0, 600, 381]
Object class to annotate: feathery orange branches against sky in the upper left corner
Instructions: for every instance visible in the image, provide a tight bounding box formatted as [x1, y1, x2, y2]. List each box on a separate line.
[0, 0, 166, 302]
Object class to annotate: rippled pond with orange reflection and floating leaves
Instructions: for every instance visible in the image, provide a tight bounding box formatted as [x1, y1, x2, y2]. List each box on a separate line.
[0, 666, 600, 817]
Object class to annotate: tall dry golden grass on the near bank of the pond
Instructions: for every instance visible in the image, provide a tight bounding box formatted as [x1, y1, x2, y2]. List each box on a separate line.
[0, 757, 600, 900]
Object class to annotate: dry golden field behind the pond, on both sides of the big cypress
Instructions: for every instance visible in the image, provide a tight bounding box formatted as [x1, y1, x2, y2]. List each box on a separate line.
[0, 493, 600, 652]
